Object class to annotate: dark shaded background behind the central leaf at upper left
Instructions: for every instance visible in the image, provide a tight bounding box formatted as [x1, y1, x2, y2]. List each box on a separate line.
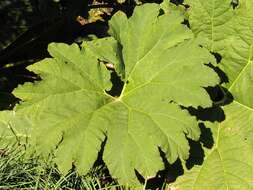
[0, 0, 183, 110]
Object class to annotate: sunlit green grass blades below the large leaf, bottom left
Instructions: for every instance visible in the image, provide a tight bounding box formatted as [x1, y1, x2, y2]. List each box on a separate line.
[0, 147, 123, 190]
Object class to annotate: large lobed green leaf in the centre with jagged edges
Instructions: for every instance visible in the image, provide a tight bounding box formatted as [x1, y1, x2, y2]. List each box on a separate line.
[1, 4, 219, 186]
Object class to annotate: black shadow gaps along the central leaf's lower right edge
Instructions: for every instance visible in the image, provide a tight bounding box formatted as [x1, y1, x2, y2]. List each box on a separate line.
[142, 86, 233, 189]
